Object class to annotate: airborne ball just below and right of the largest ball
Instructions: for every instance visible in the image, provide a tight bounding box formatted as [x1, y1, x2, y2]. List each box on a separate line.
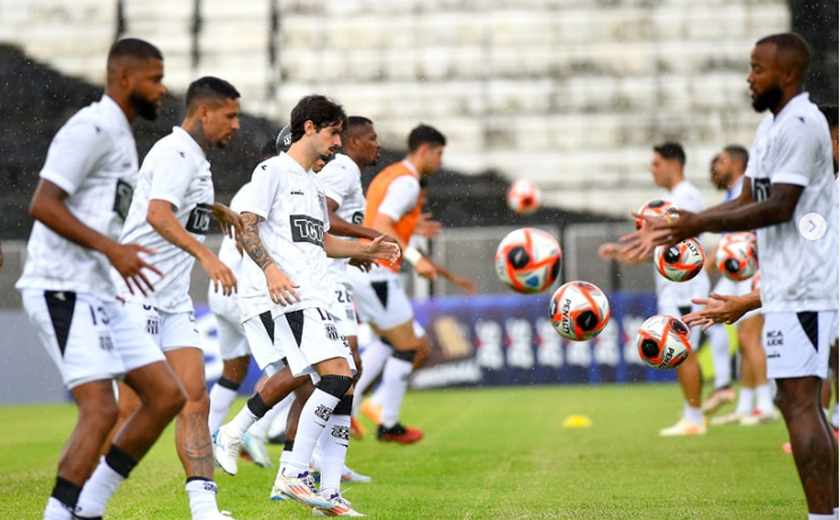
[548, 282, 610, 341]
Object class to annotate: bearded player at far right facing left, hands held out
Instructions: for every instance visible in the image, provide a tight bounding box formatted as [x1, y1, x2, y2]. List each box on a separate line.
[624, 33, 838, 520]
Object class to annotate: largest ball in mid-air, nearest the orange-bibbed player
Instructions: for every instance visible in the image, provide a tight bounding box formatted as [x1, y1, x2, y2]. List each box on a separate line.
[496, 228, 563, 294]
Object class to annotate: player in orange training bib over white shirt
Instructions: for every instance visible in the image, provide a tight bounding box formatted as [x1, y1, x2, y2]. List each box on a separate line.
[348, 125, 446, 444]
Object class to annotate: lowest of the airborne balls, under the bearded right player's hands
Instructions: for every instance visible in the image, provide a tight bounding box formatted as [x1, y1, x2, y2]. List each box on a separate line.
[636, 314, 691, 370]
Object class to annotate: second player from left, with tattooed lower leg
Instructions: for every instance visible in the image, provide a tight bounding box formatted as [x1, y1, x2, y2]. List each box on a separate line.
[104, 76, 239, 520]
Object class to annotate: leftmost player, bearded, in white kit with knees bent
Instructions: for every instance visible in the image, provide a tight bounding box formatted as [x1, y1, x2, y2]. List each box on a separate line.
[17, 38, 184, 520]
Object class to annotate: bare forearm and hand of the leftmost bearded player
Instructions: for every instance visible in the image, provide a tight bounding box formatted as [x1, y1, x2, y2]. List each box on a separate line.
[29, 179, 163, 295]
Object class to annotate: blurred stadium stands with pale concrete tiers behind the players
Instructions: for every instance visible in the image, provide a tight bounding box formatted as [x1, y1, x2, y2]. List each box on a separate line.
[0, 0, 838, 308]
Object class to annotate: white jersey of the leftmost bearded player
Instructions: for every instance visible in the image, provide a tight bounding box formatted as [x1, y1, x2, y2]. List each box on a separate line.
[16, 95, 138, 300]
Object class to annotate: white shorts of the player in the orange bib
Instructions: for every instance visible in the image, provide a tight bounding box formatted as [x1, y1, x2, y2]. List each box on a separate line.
[347, 267, 414, 330]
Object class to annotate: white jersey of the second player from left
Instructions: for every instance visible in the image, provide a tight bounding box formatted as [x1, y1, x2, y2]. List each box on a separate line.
[113, 126, 214, 312]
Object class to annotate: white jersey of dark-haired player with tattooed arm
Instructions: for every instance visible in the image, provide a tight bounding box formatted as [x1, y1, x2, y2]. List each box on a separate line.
[239, 153, 335, 321]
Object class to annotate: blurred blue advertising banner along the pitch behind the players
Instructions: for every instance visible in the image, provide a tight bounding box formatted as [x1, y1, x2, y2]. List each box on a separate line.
[196, 292, 676, 394]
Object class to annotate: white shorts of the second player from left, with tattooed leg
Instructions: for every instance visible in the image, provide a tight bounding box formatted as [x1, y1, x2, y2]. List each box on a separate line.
[125, 302, 201, 352]
